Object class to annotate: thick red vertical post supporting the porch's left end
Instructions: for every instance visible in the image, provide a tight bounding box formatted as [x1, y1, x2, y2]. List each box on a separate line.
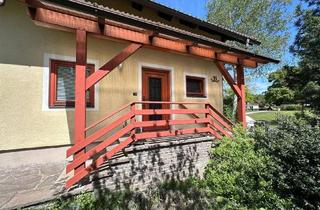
[74, 30, 87, 174]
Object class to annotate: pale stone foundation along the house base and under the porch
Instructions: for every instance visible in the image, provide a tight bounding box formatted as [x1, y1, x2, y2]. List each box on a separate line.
[0, 135, 214, 209]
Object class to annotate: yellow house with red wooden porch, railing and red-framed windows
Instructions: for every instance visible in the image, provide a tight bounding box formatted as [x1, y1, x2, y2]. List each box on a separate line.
[0, 0, 278, 208]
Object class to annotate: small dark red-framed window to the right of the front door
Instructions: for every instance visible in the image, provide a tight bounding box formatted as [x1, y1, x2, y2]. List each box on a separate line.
[186, 76, 206, 98]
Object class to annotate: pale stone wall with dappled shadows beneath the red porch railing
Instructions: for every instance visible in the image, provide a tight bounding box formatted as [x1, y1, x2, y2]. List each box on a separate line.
[63, 139, 212, 198]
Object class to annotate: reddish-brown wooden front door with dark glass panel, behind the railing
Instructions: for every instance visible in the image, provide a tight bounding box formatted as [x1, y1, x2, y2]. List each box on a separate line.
[142, 68, 170, 131]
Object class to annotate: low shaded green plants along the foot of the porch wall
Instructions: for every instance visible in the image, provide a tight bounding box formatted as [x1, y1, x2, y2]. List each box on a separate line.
[47, 177, 217, 210]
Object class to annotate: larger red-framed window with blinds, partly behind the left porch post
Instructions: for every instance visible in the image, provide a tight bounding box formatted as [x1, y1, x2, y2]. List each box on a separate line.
[49, 60, 94, 108]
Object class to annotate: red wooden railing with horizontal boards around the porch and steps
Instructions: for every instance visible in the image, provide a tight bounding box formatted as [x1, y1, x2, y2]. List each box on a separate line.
[66, 101, 233, 188]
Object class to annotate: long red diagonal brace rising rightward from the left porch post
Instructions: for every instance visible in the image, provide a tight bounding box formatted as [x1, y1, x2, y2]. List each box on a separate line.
[86, 43, 142, 89]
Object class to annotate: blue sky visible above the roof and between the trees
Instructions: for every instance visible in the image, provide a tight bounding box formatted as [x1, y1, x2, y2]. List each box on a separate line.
[156, 0, 300, 93]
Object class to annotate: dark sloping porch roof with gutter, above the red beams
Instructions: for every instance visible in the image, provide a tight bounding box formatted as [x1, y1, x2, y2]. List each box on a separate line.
[40, 0, 279, 63]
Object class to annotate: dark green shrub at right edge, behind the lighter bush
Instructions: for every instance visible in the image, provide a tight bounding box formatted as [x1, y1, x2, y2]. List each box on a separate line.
[253, 116, 320, 209]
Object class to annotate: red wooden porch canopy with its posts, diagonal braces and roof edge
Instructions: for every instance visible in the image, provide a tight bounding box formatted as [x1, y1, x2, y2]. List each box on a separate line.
[25, 0, 279, 188]
